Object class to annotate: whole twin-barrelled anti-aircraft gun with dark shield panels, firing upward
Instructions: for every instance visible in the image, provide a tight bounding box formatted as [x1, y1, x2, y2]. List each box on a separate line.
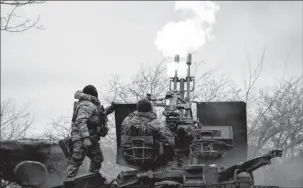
[115, 54, 282, 188]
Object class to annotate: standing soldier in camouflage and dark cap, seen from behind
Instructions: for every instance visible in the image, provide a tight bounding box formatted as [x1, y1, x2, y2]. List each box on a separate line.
[64, 85, 114, 182]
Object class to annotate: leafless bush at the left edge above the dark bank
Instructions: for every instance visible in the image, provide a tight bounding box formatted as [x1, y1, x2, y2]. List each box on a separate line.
[0, 100, 34, 140]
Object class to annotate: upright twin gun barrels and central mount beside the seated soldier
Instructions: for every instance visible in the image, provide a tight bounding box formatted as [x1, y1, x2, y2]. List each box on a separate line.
[147, 54, 233, 165]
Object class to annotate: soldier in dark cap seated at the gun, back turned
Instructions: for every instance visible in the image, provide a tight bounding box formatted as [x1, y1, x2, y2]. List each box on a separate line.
[121, 98, 175, 167]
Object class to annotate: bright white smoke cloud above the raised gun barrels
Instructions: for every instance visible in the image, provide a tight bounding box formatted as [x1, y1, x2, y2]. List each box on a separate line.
[155, 1, 220, 57]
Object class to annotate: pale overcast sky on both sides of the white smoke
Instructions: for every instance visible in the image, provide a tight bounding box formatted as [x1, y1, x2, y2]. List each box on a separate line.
[1, 1, 303, 135]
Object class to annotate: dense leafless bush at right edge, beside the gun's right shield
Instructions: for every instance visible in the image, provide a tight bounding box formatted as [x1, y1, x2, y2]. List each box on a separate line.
[250, 78, 303, 156]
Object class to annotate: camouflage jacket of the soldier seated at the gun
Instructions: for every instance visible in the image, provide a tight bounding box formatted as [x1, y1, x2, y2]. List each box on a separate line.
[121, 111, 175, 146]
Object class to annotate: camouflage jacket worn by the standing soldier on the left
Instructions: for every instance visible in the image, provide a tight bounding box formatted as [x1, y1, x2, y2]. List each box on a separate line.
[71, 91, 114, 141]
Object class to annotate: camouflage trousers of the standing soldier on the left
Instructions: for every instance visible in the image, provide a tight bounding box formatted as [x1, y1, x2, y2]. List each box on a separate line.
[67, 140, 104, 178]
